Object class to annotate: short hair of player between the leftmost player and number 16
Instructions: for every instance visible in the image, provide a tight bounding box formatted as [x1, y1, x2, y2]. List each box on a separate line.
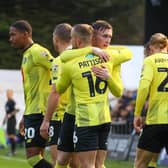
[53, 23, 72, 43]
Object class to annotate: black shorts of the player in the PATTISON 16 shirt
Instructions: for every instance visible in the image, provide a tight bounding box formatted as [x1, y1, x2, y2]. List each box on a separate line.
[73, 123, 110, 152]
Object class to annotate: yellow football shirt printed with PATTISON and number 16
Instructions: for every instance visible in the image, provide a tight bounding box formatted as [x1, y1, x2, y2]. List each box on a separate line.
[56, 54, 113, 127]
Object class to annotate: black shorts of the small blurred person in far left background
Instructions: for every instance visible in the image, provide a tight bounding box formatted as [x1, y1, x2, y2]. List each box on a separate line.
[7, 117, 16, 135]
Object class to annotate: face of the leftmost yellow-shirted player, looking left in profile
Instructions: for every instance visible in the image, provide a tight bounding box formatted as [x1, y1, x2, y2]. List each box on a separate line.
[9, 27, 25, 49]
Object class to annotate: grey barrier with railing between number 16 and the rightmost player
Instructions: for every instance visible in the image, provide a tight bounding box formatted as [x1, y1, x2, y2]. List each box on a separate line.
[107, 122, 138, 160]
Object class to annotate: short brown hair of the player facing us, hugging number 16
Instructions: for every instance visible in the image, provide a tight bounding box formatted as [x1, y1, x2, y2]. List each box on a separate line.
[92, 20, 112, 31]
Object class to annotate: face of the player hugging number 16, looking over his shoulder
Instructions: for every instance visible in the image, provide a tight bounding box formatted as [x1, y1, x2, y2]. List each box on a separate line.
[92, 29, 112, 49]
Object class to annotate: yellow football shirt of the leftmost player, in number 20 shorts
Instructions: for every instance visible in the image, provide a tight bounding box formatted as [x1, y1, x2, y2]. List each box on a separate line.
[21, 44, 53, 115]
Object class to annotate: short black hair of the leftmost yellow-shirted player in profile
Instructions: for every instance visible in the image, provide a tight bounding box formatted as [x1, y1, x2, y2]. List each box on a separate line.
[11, 20, 32, 35]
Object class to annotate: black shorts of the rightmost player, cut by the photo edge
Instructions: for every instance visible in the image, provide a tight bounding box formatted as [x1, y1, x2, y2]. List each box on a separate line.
[138, 124, 168, 153]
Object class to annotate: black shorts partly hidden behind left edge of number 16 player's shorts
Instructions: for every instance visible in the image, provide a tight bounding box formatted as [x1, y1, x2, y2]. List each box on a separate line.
[57, 113, 75, 152]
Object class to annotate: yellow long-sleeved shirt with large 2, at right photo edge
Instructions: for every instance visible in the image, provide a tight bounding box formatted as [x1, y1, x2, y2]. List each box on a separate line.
[135, 53, 168, 124]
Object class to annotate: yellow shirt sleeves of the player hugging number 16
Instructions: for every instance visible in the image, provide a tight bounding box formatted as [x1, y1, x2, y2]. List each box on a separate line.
[60, 46, 132, 97]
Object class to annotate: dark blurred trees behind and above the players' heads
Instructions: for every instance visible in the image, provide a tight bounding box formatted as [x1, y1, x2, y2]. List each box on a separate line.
[0, 0, 144, 69]
